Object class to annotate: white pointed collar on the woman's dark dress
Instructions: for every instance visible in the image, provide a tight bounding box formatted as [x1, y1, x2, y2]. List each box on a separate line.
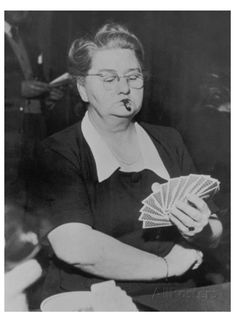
[81, 112, 170, 182]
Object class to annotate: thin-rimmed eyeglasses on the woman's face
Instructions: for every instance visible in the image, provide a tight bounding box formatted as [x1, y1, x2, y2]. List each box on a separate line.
[87, 72, 144, 90]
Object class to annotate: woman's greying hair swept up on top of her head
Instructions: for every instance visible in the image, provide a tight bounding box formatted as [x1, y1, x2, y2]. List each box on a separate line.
[69, 23, 144, 78]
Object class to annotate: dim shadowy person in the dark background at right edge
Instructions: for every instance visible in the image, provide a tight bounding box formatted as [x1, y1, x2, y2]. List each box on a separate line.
[184, 72, 230, 201]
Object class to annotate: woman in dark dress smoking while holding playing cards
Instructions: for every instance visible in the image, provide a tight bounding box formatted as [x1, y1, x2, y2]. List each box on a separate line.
[34, 24, 222, 295]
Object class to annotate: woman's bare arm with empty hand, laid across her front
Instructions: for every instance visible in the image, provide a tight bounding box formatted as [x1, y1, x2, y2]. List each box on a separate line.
[48, 223, 203, 280]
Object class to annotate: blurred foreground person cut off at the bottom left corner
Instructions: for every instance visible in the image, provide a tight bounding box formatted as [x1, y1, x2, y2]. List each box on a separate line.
[5, 205, 42, 311]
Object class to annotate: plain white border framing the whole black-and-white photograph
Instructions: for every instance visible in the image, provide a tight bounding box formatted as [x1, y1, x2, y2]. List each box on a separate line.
[0, 0, 236, 320]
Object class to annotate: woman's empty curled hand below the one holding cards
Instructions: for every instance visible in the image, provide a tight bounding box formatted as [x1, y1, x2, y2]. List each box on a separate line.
[165, 244, 203, 277]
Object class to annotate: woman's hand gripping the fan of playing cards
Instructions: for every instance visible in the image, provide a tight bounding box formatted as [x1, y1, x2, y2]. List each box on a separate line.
[169, 195, 211, 238]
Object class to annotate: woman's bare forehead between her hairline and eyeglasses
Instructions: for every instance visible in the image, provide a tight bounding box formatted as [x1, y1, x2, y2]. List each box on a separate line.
[91, 49, 140, 72]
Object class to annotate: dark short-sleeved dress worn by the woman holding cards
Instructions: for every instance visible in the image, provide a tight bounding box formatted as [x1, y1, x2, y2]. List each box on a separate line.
[31, 119, 218, 297]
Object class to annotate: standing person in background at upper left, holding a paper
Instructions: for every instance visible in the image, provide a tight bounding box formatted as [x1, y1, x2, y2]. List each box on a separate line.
[5, 11, 63, 198]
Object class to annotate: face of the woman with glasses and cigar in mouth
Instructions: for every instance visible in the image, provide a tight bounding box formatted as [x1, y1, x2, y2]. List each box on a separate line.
[78, 49, 143, 118]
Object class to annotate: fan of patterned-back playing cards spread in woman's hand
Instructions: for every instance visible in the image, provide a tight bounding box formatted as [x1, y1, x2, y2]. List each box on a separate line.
[139, 174, 220, 228]
